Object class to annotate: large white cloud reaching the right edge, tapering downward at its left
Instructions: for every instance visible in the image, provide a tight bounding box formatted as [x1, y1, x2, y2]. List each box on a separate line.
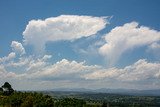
[99, 22, 160, 65]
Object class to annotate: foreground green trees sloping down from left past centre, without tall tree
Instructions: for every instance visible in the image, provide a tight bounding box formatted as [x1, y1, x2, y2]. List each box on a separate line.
[0, 91, 107, 107]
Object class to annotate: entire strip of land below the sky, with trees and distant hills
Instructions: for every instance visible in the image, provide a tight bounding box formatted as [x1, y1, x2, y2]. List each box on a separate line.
[0, 82, 160, 107]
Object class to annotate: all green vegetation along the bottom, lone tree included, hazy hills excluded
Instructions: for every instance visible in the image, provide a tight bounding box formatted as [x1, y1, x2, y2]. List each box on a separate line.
[0, 82, 160, 107]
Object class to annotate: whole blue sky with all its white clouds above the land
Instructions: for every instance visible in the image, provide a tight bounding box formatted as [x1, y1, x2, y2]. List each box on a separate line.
[0, 0, 160, 90]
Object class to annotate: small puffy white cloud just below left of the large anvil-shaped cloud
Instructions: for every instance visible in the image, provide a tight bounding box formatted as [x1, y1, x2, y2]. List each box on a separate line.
[11, 41, 25, 55]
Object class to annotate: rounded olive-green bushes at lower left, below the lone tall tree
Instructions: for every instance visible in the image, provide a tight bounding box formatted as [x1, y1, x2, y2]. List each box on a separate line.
[0, 92, 54, 107]
